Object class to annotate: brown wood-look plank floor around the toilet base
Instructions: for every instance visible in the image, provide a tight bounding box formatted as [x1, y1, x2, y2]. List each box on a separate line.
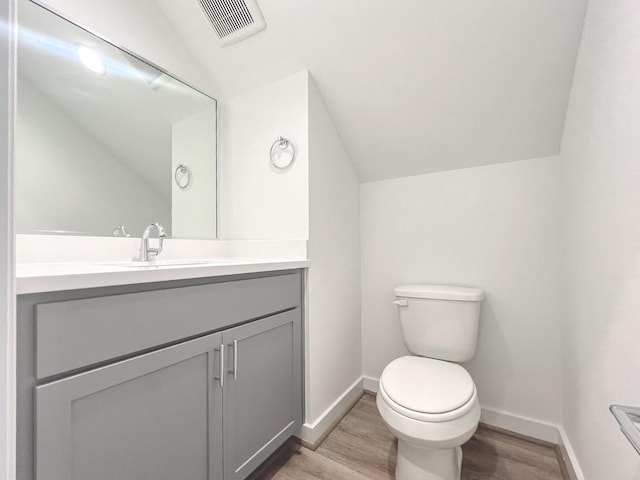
[251, 394, 565, 480]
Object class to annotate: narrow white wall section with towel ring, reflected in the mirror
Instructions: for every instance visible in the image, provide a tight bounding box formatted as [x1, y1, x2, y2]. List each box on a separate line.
[171, 108, 218, 238]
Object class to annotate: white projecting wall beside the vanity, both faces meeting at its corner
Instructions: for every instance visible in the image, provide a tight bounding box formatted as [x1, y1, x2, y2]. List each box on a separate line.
[219, 71, 362, 434]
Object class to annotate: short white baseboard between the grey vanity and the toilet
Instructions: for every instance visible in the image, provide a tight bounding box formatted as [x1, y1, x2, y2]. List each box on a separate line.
[297, 377, 364, 450]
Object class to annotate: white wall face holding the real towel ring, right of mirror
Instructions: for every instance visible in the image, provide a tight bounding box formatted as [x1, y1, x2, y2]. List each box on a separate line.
[218, 71, 309, 239]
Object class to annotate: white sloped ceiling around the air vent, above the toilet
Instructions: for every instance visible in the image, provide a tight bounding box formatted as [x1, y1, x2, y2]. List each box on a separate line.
[156, 0, 587, 182]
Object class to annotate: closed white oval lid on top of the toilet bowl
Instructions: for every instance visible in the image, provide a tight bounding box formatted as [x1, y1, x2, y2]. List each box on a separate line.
[380, 356, 475, 414]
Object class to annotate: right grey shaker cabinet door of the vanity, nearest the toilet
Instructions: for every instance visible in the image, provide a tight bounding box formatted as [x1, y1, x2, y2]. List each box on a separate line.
[223, 309, 302, 480]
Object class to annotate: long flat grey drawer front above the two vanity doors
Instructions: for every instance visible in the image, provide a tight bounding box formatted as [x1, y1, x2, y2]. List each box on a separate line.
[36, 273, 301, 379]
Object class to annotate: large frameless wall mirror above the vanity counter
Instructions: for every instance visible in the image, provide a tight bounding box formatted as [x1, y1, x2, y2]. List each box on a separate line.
[15, 0, 217, 238]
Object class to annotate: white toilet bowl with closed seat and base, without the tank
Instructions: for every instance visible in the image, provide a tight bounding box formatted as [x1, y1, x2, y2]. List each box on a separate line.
[376, 356, 480, 480]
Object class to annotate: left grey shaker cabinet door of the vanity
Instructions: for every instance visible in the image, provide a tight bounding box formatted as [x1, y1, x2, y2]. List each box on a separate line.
[36, 333, 224, 480]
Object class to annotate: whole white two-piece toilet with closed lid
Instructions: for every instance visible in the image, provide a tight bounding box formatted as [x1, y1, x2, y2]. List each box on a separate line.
[376, 285, 484, 480]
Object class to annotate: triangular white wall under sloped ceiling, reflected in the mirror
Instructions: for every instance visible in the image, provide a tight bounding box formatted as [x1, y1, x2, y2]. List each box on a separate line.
[15, 79, 171, 235]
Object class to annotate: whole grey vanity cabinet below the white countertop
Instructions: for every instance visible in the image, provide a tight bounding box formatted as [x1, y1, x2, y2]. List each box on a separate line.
[17, 262, 303, 480]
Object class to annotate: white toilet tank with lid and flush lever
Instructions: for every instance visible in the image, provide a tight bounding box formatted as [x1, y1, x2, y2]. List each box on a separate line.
[394, 285, 484, 362]
